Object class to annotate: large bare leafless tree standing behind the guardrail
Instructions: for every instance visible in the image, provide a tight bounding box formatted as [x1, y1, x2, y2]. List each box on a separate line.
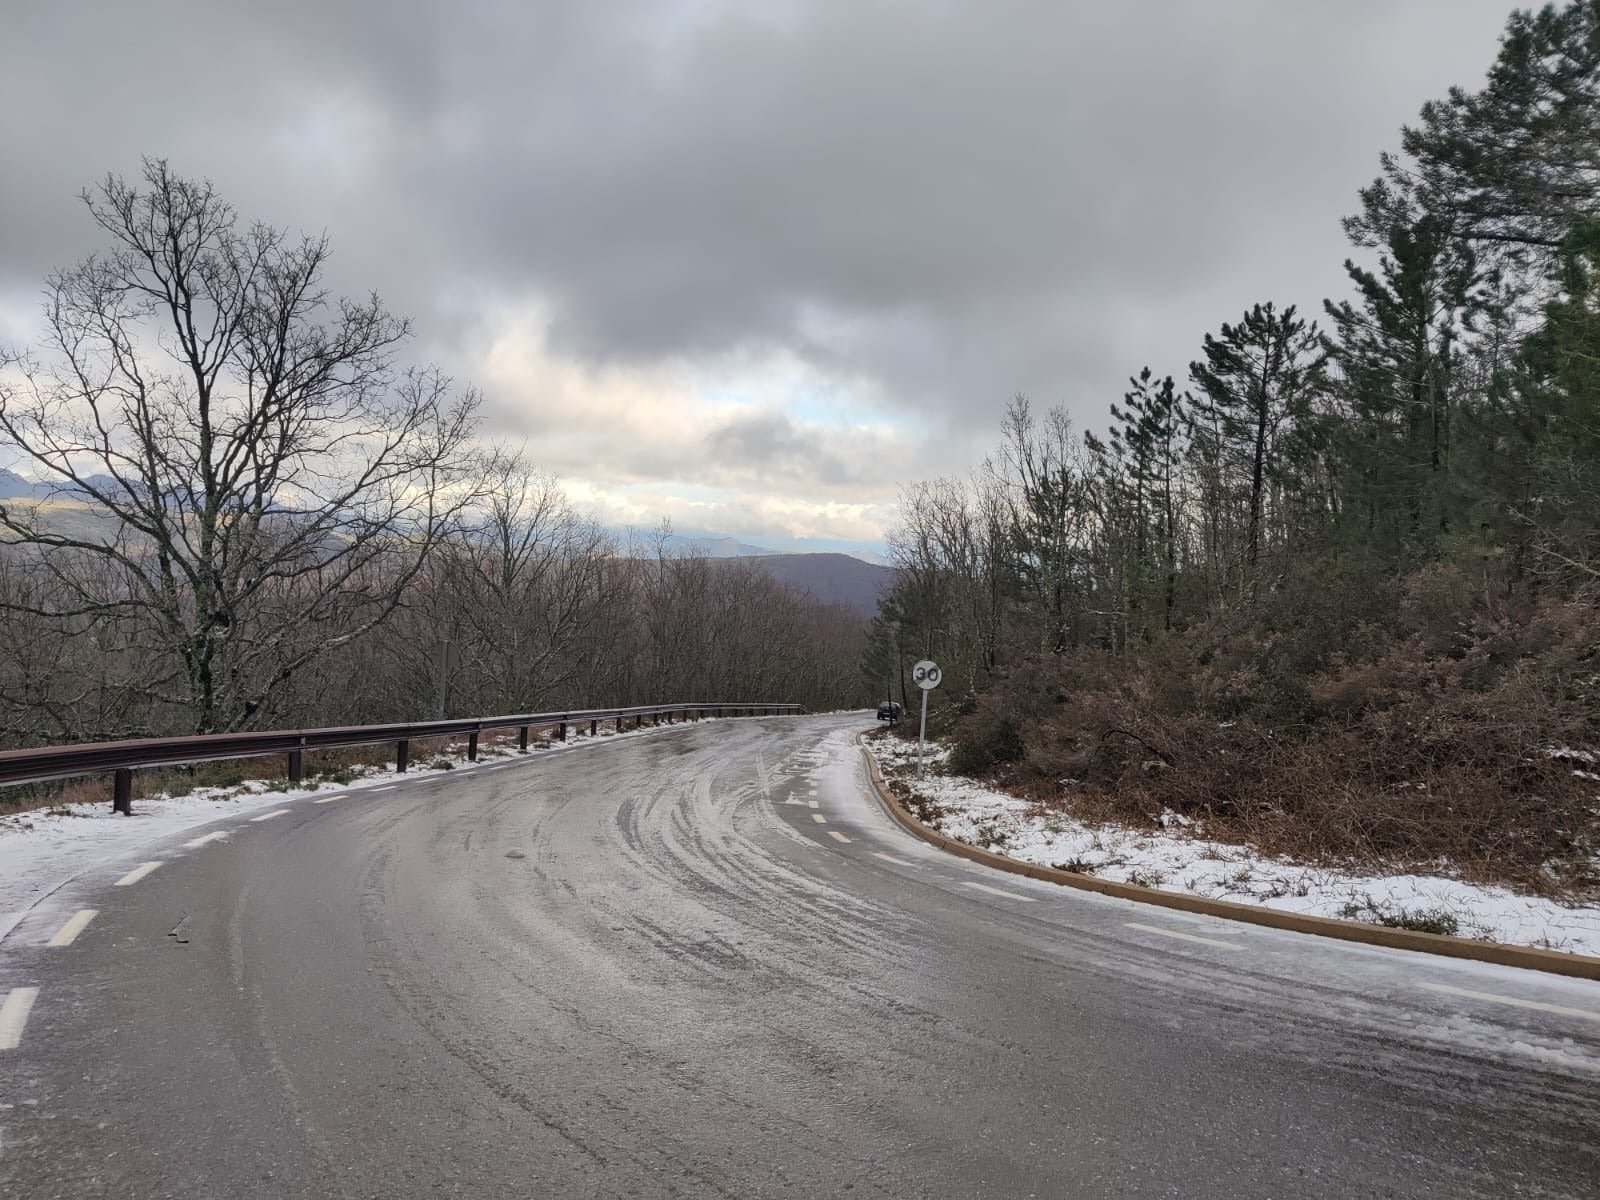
[0, 162, 478, 731]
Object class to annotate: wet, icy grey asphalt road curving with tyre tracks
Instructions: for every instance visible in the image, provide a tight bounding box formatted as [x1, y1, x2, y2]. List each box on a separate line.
[0, 717, 1600, 1200]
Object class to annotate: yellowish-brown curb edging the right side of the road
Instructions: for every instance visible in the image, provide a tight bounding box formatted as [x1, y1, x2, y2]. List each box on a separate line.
[858, 739, 1600, 979]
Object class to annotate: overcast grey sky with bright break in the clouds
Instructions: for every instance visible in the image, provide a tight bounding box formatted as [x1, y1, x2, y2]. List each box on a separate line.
[0, 0, 1510, 547]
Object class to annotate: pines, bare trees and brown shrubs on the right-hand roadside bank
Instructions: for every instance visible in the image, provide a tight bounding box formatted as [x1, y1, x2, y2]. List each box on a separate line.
[864, 3, 1600, 901]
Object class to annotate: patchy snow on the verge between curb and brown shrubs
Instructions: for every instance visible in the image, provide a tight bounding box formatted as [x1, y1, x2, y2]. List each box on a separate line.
[870, 738, 1600, 955]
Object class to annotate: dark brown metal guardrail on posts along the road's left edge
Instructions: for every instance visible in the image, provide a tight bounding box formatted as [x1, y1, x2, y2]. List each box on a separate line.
[0, 702, 805, 814]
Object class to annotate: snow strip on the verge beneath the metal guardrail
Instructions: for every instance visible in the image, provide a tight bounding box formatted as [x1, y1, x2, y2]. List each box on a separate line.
[0, 718, 697, 942]
